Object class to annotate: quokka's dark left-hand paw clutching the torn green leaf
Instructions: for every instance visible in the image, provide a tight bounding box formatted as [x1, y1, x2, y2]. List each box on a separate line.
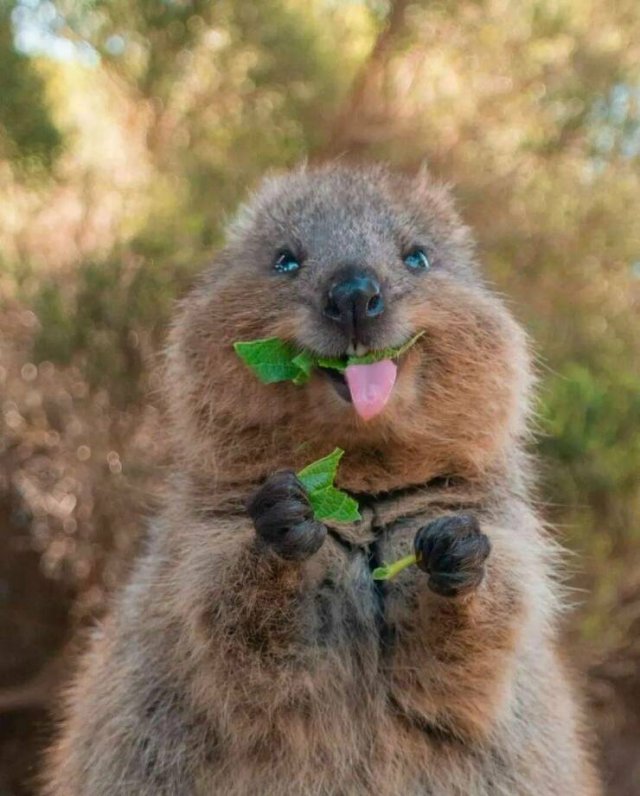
[247, 470, 327, 561]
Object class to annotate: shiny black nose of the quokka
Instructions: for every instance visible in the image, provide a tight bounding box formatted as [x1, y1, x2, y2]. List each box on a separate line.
[324, 268, 384, 337]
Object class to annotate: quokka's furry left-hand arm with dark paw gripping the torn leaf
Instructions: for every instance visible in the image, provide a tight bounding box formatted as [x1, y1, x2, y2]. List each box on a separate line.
[176, 472, 327, 668]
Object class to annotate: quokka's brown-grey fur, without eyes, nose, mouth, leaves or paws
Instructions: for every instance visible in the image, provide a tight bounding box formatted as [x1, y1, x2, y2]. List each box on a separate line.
[45, 167, 599, 796]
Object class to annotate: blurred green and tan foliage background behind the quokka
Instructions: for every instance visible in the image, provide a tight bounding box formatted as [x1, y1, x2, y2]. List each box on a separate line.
[0, 0, 640, 796]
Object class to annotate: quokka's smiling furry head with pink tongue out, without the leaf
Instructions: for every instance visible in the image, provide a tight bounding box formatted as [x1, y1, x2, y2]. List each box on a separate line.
[169, 166, 529, 490]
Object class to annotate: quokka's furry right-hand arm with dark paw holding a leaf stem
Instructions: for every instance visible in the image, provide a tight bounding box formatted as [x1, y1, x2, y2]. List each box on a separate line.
[384, 514, 551, 738]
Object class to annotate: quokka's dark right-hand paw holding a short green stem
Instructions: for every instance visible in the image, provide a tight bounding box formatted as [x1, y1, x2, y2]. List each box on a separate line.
[413, 514, 491, 597]
